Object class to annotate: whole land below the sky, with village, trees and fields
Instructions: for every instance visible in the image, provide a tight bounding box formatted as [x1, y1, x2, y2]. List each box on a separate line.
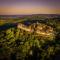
[0, 14, 60, 60]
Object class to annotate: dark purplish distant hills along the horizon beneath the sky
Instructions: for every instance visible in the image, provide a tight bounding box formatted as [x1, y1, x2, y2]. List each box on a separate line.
[0, 14, 60, 18]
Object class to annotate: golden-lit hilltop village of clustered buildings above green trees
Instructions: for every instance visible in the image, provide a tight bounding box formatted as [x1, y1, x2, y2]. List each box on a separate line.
[17, 22, 54, 37]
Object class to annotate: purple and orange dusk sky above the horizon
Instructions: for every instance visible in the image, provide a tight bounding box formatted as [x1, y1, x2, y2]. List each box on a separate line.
[0, 0, 60, 15]
